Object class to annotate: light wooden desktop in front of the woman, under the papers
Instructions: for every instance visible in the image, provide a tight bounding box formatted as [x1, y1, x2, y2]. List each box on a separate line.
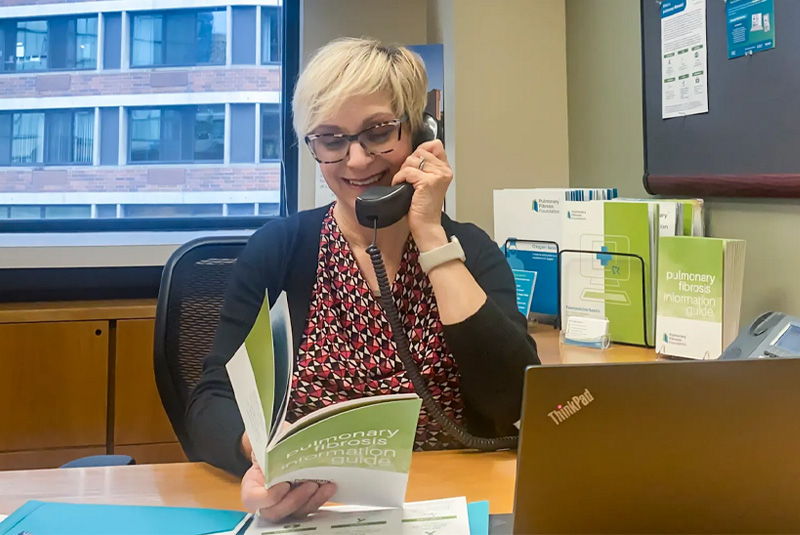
[0, 451, 516, 514]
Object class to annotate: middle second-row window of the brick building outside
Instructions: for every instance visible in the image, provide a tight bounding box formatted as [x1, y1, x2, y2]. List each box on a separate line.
[128, 105, 225, 163]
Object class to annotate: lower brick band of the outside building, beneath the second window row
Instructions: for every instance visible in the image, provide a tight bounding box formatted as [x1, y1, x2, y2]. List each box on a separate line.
[0, 168, 281, 193]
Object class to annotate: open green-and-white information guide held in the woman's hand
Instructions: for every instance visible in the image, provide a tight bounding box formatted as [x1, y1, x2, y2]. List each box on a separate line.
[227, 294, 422, 507]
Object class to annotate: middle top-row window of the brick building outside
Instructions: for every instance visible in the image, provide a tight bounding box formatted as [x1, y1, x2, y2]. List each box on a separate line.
[131, 9, 227, 67]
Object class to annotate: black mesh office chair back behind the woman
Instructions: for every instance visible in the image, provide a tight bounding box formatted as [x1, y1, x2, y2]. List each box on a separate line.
[153, 237, 247, 461]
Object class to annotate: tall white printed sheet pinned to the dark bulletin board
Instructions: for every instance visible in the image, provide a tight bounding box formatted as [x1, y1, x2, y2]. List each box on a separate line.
[661, 0, 708, 119]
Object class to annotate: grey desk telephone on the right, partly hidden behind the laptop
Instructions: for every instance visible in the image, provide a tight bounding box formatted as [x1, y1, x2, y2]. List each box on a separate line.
[720, 312, 800, 360]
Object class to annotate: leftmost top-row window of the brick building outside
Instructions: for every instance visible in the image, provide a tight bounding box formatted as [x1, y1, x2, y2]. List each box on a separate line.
[0, 15, 97, 72]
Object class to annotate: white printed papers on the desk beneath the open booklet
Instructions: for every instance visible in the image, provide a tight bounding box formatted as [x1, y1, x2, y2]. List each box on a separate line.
[244, 496, 469, 535]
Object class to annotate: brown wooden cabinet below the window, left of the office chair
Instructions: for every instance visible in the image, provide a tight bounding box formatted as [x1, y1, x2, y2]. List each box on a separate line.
[0, 300, 185, 470]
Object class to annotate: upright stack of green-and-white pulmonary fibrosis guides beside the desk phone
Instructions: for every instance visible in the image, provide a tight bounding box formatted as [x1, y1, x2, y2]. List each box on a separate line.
[656, 236, 745, 359]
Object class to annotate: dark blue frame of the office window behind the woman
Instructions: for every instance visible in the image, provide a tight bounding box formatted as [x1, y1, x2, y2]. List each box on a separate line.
[0, 0, 300, 234]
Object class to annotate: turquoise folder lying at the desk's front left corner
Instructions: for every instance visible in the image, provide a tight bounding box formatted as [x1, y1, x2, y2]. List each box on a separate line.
[0, 501, 246, 535]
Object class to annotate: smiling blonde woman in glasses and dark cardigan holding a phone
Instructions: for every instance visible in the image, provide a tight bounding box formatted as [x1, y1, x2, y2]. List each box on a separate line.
[188, 39, 539, 520]
